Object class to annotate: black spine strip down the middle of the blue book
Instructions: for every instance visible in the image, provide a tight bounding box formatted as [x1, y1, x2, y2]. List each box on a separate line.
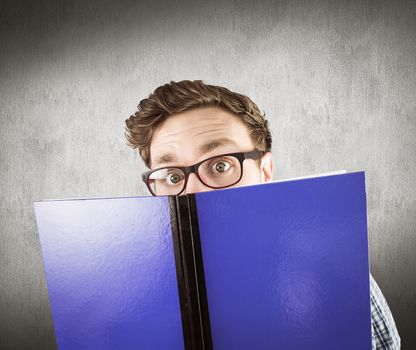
[169, 195, 212, 350]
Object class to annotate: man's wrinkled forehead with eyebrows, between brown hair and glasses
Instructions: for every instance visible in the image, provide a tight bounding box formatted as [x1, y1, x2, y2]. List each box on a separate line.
[150, 107, 254, 168]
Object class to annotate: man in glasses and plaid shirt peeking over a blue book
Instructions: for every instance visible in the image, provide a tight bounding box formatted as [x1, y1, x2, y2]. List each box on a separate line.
[126, 81, 400, 349]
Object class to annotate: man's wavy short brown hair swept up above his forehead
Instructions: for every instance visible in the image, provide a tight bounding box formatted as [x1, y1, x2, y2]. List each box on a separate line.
[125, 80, 272, 168]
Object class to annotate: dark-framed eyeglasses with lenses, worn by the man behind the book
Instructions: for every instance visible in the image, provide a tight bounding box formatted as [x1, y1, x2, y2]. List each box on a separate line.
[142, 150, 264, 196]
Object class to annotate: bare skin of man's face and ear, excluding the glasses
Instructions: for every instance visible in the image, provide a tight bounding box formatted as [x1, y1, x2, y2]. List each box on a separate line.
[150, 107, 273, 193]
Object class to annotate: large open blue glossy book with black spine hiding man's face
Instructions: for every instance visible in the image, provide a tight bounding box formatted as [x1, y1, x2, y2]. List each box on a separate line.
[35, 172, 371, 350]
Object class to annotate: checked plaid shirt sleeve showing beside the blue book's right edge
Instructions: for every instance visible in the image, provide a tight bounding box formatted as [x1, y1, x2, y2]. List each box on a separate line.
[370, 275, 400, 350]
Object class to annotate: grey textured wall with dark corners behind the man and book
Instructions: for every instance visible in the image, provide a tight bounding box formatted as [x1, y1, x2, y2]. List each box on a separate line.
[0, 0, 416, 349]
